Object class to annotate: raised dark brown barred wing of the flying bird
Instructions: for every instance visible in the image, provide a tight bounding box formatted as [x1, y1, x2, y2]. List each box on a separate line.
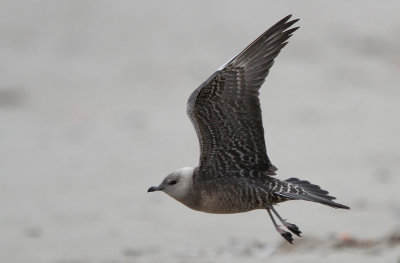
[187, 15, 298, 177]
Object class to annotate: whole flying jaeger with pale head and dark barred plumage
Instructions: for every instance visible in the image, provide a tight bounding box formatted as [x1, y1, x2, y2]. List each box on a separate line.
[148, 15, 349, 243]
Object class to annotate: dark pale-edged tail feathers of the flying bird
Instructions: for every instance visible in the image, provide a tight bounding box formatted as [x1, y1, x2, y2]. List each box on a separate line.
[277, 178, 350, 209]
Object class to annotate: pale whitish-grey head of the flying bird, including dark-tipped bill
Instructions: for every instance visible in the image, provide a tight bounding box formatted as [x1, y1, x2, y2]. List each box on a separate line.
[147, 167, 194, 202]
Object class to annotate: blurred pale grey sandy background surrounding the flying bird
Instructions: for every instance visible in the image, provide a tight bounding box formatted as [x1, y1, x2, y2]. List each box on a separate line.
[0, 0, 400, 263]
